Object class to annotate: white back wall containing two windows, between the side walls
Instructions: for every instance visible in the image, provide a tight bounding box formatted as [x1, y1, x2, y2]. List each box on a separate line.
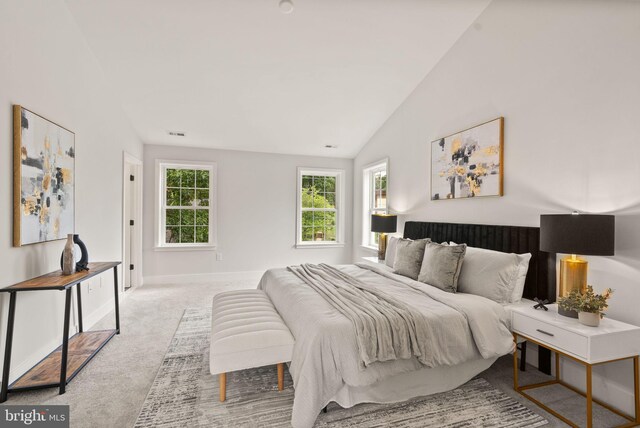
[143, 145, 353, 283]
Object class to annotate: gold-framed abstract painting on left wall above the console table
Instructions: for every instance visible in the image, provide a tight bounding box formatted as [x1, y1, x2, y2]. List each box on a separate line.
[13, 105, 75, 247]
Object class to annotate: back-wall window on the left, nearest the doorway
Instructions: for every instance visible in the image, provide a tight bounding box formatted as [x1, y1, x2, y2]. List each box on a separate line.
[157, 161, 217, 248]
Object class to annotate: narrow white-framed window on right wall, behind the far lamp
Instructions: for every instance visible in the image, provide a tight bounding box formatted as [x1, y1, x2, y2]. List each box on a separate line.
[362, 159, 389, 249]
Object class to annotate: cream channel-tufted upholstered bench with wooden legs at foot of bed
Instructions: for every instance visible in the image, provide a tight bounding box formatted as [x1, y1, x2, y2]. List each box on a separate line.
[209, 290, 294, 401]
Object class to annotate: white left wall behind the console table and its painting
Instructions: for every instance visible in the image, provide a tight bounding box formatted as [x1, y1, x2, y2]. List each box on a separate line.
[0, 0, 142, 379]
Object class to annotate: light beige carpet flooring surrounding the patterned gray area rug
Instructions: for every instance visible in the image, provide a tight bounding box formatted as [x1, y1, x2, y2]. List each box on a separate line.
[0, 280, 624, 428]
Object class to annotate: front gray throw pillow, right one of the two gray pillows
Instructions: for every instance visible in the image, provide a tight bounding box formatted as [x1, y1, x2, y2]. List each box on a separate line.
[418, 242, 467, 293]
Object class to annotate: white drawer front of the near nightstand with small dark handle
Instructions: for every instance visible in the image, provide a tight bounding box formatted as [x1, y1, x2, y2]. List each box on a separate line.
[513, 313, 589, 358]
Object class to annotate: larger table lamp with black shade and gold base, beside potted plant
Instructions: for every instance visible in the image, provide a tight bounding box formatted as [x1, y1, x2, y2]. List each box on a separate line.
[540, 212, 615, 318]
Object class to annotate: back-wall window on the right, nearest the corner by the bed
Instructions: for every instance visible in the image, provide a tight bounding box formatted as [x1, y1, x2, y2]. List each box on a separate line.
[297, 168, 344, 247]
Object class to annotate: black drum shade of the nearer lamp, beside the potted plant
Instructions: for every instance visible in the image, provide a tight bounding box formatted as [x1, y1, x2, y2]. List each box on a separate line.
[540, 214, 616, 256]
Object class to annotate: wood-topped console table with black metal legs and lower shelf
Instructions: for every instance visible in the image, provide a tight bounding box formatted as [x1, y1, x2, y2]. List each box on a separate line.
[0, 262, 120, 403]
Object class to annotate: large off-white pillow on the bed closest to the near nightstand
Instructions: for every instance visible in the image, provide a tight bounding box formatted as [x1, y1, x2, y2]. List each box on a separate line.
[458, 247, 531, 303]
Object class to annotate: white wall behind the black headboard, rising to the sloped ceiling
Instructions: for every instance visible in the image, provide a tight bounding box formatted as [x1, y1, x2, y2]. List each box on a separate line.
[353, 0, 640, 412]
